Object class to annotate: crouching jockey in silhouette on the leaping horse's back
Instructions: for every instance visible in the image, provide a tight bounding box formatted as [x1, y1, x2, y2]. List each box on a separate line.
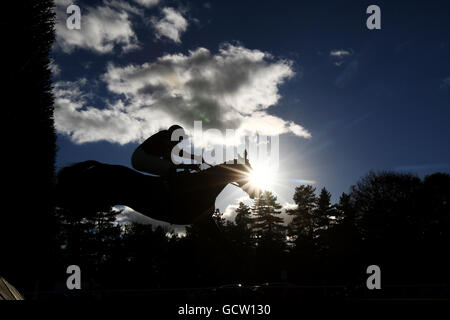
[131, 125, 200, 177]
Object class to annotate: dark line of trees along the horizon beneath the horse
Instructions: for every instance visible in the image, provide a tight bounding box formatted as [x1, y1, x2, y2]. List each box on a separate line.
[52, 172, 450, 296]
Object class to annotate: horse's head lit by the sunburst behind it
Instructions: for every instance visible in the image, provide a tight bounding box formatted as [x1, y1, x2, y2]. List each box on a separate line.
[226, 150, 261, 199]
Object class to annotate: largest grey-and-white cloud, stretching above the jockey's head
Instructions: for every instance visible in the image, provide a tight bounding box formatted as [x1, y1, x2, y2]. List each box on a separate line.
[55, 44, 311, 145]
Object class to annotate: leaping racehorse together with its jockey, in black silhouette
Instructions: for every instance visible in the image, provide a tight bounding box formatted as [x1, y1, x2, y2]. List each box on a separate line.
[56, 125, 260, 224]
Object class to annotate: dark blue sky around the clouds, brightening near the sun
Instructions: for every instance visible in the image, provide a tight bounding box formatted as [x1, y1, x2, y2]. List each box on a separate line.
[54, 0, 450, 210]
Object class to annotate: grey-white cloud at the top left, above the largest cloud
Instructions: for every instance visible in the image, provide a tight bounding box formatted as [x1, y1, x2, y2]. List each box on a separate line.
[55, 0, 139, 54]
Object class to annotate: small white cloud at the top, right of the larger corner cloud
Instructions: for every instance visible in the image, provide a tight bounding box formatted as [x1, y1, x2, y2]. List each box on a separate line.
[151, 8, 188, 43]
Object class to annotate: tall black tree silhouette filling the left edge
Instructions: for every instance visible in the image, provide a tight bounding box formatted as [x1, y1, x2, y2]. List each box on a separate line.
[0, 0, 57, 298]
